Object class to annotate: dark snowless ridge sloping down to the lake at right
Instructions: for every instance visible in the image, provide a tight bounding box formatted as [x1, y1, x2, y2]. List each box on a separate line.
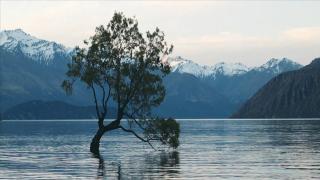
[231, 58, 320, 118]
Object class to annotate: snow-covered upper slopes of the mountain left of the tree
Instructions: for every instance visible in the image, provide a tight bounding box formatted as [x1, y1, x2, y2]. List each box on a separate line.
[0, 29, 73, 65]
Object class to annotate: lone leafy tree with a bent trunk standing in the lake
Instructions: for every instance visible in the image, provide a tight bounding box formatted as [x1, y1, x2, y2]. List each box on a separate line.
[62, 12, 180, 155]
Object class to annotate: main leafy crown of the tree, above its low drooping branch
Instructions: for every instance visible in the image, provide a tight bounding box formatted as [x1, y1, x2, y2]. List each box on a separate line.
[62, 13, 172, 118]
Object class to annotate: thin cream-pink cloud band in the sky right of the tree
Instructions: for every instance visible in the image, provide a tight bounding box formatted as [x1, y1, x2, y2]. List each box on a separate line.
[175, 27, 320, 48]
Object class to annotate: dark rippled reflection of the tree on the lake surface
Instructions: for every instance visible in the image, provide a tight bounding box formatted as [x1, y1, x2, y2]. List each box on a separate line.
[94, 151, 180, 179]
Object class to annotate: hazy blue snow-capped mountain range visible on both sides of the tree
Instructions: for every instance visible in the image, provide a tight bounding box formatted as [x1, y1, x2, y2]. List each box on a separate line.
[0, 29, 302, 118]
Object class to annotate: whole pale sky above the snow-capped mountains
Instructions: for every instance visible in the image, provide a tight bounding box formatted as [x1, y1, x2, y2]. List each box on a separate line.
[0, 0, 320, 66]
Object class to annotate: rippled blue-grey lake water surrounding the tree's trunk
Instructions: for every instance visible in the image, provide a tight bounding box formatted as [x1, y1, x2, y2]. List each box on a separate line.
[0, 120, 320, 179]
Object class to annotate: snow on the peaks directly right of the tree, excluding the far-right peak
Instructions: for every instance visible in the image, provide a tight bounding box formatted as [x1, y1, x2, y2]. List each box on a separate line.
[168, 56, 250, 77]
